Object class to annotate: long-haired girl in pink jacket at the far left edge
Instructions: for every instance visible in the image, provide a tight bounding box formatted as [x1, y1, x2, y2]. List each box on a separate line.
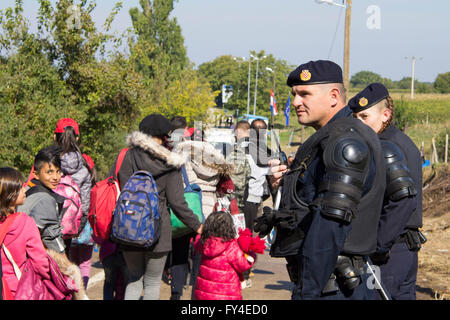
[0, 168, 50, 296]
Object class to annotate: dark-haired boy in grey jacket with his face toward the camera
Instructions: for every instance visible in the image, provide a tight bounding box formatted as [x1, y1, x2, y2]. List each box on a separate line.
[18, 146, 66, 253]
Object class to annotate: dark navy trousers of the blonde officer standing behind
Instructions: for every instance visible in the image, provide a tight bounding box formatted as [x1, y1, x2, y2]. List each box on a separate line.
[376, 242, 418, 300]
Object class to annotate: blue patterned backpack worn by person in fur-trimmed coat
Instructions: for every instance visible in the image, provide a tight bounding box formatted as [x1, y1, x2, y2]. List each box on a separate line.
[111, 171, 161, 248]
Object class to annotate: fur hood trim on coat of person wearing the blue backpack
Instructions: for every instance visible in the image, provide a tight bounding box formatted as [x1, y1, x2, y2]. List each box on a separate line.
[127, 131, 185, 168]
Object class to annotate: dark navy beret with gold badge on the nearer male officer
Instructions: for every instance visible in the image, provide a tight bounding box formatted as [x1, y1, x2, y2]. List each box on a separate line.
[287, 60, 344, 87]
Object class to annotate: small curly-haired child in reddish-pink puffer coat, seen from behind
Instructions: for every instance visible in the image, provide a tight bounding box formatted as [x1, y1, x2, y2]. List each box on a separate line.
[194, 212, 255, 300]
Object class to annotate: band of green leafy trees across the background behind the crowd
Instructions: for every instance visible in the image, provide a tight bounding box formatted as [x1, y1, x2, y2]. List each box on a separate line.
[0, 0, 450, 176]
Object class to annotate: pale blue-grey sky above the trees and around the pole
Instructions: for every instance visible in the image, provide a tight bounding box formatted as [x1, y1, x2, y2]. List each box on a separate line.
[0, 0, 450, 82]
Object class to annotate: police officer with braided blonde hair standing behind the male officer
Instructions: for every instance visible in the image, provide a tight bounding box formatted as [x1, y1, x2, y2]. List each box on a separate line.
[349, 83, 426, 300]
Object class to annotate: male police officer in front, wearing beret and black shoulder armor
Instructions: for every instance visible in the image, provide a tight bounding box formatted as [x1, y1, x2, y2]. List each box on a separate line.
[255, 60, 385, 300]
